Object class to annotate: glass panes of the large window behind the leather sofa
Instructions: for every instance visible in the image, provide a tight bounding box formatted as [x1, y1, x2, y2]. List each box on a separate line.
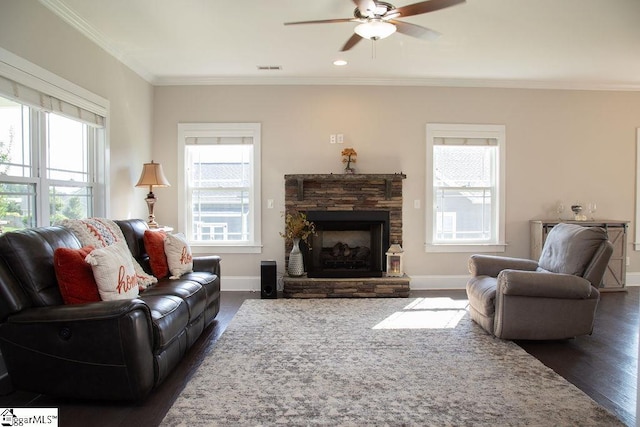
[0, 97, 102, 231]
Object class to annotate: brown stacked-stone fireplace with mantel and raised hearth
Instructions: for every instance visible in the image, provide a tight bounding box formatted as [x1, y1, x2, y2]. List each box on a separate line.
[284, 173, 409, 298]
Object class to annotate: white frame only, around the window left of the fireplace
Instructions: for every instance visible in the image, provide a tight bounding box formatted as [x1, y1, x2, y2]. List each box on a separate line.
[178, 123, 262, 253]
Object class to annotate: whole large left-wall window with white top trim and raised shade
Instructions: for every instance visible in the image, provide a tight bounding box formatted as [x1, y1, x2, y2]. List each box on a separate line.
[0, 50, 108, 232]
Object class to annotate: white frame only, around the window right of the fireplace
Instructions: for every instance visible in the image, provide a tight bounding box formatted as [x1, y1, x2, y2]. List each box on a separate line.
[424, 123, 506, 252]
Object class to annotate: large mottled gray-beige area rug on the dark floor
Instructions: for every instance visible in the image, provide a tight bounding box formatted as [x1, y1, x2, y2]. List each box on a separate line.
[163, 298, 623, 426]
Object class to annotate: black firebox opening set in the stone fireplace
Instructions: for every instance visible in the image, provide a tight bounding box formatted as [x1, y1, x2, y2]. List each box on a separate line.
[304, 211, 389, 278]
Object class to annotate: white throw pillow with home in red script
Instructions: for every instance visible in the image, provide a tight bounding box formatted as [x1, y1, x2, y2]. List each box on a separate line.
[85, 242, 139, 301]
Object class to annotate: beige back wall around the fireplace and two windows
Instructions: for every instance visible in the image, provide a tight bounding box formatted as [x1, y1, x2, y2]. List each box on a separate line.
[154, 86, 640, 286]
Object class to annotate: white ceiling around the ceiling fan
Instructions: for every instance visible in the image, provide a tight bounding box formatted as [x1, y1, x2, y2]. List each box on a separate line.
[40, 0, 640, 90]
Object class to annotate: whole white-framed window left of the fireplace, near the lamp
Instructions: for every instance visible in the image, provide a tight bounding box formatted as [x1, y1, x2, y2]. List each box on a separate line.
[178, 123, 261, 253]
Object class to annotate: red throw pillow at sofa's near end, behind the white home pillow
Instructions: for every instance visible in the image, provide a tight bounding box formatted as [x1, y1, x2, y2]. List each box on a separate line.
[53, 246, 101, 304]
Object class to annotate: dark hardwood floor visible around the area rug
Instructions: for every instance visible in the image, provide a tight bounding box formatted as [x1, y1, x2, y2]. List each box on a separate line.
[0, 287, 640, 427]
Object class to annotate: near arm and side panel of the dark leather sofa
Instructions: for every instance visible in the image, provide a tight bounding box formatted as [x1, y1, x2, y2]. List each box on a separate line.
[0, 299, 154, 400]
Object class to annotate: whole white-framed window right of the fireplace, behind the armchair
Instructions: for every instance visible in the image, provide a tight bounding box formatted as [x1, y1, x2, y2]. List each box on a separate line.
[425, 124, 505, 252]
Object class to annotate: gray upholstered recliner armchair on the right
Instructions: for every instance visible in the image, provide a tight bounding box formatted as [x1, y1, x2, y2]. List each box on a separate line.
[467, 223, 613, 340]
